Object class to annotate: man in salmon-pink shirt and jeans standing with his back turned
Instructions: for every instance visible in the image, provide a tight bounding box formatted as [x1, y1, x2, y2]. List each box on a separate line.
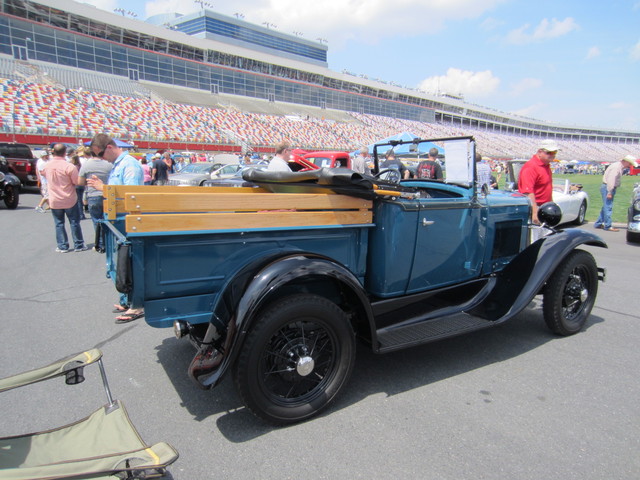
[42, 143, 87, 253]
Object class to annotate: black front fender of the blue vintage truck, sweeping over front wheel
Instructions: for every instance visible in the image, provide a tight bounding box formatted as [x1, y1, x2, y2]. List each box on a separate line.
[468, 228, 607, 321]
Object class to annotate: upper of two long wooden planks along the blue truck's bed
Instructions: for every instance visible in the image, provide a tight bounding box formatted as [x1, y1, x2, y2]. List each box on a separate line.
[124, 189, 373, 213]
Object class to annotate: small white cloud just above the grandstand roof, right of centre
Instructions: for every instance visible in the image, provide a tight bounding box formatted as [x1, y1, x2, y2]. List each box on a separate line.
[418, 67, 500, 98]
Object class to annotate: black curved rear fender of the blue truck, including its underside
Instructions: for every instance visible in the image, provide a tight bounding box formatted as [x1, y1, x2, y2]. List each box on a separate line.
[198, 253, 375, 388]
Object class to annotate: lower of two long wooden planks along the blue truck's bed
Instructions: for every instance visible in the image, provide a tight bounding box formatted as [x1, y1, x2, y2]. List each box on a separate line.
[125, 210, 373, 233]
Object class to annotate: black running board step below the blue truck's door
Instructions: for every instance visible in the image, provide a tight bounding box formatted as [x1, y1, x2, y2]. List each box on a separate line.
[377, 312, 492, 353]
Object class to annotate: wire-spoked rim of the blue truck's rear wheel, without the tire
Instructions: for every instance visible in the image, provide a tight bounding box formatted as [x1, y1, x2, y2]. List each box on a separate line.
[258, 321, 338, 407]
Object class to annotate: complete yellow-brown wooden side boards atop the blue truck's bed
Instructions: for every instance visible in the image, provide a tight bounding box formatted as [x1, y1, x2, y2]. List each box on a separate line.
[105, 185, 373, 233]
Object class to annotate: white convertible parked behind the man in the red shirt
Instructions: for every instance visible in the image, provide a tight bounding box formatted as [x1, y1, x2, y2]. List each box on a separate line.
[507, 160, 589, 225]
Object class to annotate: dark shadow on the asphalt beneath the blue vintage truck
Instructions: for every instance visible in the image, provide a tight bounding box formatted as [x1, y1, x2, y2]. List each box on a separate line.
[157, 307, 604, 443]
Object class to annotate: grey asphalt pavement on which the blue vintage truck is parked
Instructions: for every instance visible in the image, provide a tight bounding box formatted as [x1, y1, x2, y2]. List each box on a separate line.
[0, 192, 640, 480]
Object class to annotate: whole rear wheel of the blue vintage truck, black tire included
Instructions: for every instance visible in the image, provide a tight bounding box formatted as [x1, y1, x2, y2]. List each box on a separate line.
[234, 294, 355, 425]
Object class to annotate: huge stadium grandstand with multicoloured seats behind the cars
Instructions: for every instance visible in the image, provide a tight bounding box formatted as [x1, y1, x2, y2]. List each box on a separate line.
[0, 0, 640, 161]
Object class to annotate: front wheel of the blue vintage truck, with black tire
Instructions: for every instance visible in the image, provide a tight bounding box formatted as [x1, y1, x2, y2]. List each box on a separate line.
[542, 250, 598, 335]
